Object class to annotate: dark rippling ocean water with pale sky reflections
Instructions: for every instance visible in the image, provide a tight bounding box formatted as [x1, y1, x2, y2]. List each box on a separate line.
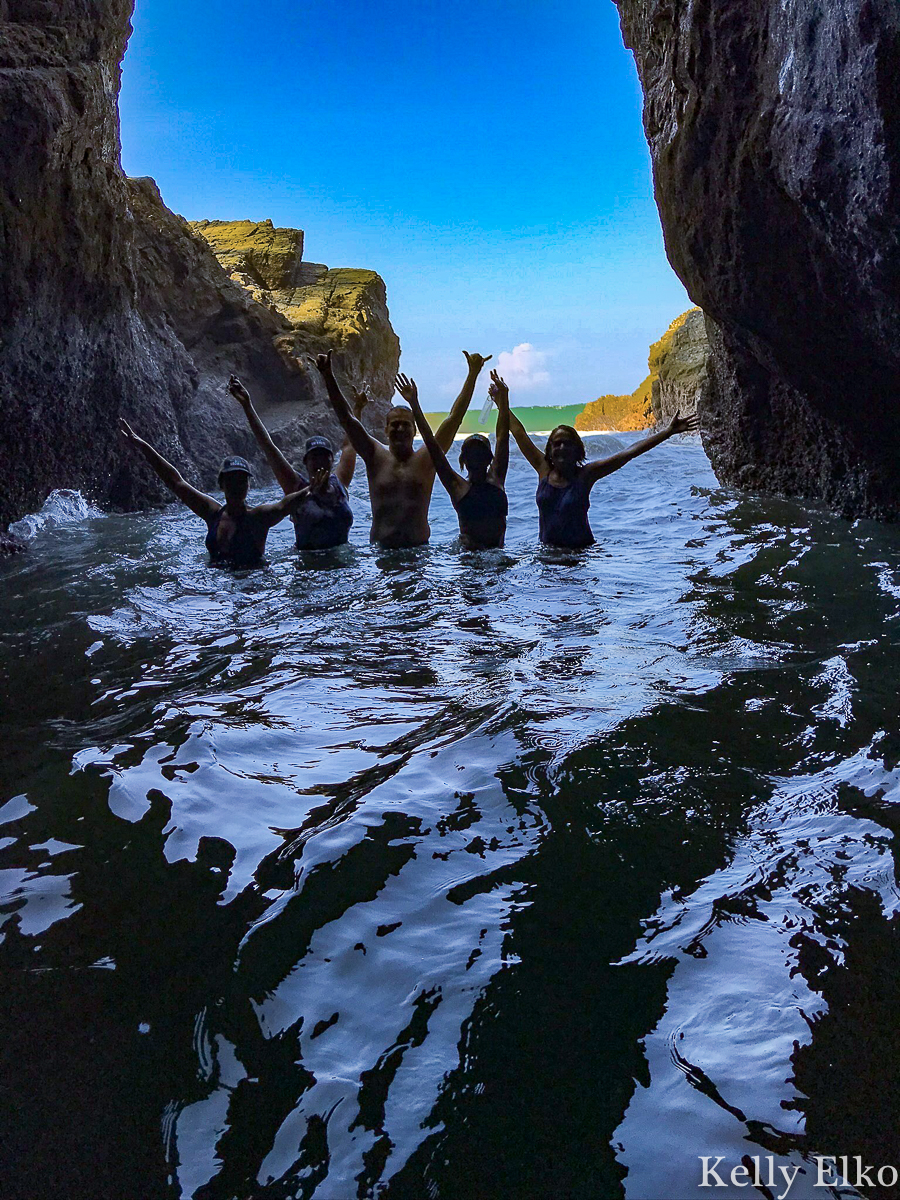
[0, 436, 900, 1200]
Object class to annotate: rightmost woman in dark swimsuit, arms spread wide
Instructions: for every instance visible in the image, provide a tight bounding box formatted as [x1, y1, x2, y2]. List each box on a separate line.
[504, 372, 697, 550]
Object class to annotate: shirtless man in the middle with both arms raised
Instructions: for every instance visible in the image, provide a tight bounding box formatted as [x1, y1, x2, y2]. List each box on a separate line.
[311, 350, 491, 547]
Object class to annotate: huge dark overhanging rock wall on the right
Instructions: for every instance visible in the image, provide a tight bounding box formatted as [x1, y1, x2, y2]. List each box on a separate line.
[617, 0, 900, 520]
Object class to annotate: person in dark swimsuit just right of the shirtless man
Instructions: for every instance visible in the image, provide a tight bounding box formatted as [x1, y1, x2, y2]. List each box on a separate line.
[396, 372, 509, 550]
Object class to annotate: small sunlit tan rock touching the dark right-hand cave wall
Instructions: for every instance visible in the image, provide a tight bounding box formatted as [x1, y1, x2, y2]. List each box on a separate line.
[648, 308, 709, 425]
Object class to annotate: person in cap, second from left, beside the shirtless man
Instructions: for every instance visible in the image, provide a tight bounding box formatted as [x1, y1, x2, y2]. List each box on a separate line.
[228, 376, 368, 550]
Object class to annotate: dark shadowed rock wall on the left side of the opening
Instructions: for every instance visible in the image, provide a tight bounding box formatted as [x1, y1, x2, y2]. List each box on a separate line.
[0, 0, 396, 528]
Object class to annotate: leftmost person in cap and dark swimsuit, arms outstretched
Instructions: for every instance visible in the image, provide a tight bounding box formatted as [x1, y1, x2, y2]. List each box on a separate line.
[120, 418, 316, 566]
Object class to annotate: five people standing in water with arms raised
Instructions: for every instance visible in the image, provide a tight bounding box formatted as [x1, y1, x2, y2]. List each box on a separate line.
[121, 350, 697, 566]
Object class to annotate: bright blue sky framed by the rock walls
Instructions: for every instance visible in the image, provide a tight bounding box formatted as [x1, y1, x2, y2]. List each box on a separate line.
[121, 0, 690, 409]
